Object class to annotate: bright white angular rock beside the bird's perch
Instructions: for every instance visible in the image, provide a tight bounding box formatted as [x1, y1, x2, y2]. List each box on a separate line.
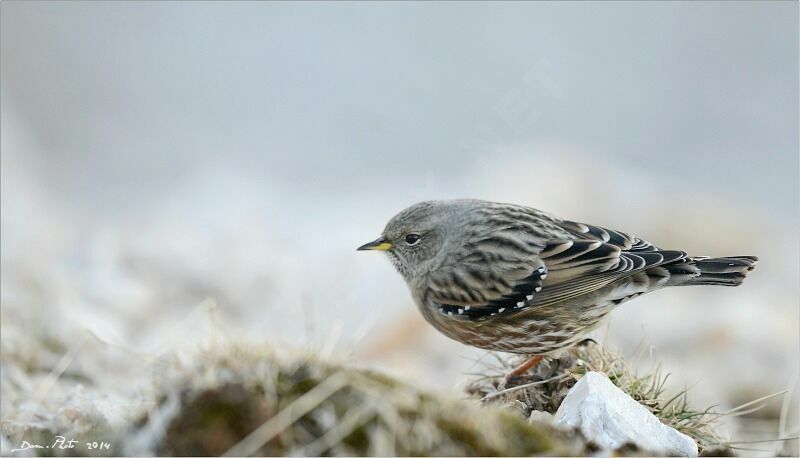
[555, 372, 697, 457]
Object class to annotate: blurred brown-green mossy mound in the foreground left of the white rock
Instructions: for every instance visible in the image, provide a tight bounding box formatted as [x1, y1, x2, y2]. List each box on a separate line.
[137, 348, 585, 456]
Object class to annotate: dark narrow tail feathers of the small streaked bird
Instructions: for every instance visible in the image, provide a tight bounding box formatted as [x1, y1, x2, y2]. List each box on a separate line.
[663, 256, 758, 286]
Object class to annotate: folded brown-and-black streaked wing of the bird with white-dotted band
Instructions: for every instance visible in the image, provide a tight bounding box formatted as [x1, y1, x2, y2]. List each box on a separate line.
[428, 221, 686, 320]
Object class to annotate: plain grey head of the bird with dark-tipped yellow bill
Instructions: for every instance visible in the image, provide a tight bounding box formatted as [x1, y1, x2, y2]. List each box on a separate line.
[358, 200, 479, 280]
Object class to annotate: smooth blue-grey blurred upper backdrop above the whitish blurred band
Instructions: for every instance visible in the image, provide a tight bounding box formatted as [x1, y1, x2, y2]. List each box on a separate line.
[2, 1, 798, 218]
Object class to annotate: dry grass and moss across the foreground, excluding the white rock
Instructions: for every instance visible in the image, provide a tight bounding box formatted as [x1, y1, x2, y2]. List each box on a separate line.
[2, 320, 792, 456]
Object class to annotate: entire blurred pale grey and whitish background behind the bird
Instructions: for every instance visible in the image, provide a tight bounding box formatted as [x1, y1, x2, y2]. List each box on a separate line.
[0, 2, 800, 454]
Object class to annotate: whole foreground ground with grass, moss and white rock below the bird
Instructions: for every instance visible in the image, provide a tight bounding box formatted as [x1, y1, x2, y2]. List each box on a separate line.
[0, 323, 796, 456]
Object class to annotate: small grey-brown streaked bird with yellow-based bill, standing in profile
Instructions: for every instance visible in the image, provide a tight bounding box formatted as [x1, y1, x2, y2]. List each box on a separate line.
[358, 199, 758, 385]
